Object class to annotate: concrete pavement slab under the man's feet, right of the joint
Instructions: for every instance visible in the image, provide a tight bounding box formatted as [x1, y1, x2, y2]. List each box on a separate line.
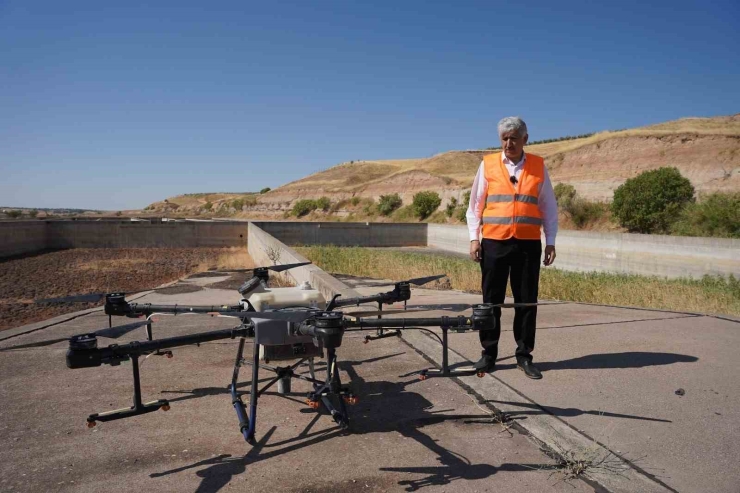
[342, 277, 740, 492]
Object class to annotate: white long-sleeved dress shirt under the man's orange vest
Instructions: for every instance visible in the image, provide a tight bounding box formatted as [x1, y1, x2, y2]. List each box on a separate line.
[465, 153, 558, 246]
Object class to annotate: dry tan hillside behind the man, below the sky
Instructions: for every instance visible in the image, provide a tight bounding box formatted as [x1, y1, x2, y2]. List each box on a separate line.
[150, 114, 740, 217]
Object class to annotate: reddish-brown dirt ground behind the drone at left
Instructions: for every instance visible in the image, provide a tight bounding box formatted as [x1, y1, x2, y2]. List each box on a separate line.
[0, 248, 251, 330]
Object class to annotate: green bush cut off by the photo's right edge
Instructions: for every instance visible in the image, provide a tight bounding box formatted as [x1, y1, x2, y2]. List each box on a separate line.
[671, 192, 740, 238]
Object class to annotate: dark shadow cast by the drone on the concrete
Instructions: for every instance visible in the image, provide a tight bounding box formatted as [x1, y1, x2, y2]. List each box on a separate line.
[151, 353, 548, 493]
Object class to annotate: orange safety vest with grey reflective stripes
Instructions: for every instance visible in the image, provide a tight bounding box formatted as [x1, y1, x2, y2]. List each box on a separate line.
[481, 152, 545, 240]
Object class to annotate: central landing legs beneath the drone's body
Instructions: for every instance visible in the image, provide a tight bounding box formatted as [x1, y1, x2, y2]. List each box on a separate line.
[229, 338, 357, 445]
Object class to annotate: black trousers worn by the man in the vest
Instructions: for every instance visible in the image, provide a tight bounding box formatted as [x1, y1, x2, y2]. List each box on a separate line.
[478, 238, 542, 363]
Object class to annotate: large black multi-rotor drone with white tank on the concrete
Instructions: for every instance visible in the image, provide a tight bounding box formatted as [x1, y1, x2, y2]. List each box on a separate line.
[8, 262, 537, 445]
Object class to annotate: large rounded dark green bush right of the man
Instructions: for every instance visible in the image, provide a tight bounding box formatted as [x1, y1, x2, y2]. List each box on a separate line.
[612, 168, 694, 233]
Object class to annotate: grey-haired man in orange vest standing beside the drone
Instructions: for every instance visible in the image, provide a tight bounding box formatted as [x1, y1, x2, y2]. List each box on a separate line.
[466, 117, 558, 379]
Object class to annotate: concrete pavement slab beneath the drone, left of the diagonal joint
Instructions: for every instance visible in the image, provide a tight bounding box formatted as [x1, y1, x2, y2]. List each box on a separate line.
[0, 279, 594, 493]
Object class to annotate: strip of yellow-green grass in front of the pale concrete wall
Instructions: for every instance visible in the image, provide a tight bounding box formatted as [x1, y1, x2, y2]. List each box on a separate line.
[296, 246, 740, 316]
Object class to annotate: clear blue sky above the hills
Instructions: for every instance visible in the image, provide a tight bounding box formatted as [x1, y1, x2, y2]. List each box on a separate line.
[0, 0, 740, 210]
